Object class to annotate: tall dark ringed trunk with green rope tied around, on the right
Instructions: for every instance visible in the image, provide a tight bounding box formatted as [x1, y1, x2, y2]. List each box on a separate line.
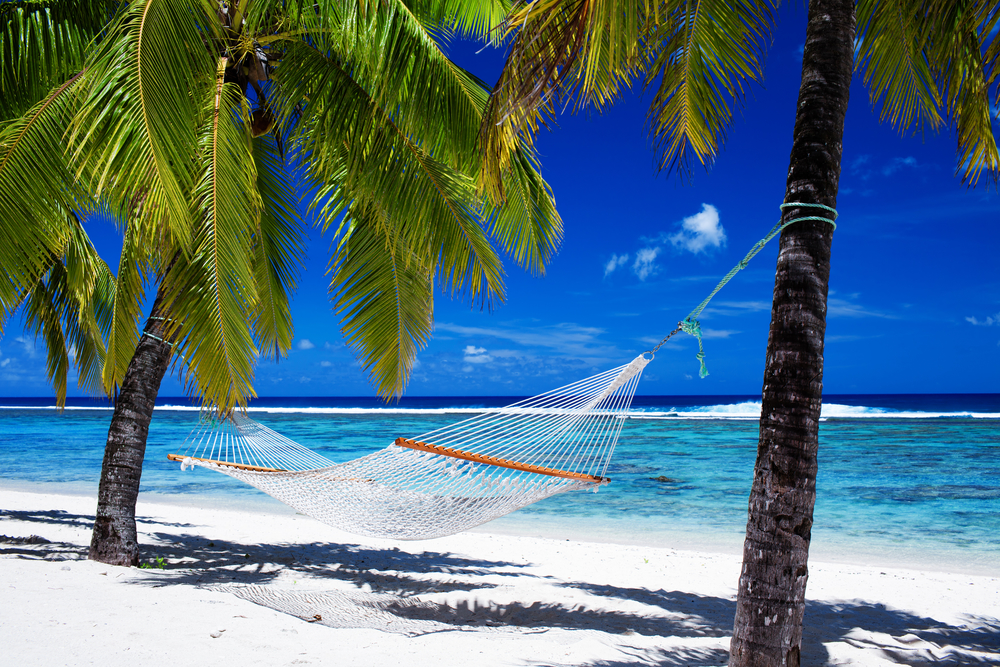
[729, 0, 854, 667]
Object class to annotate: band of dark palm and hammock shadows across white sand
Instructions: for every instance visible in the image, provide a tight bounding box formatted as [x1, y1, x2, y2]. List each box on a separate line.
[0, 512, 1000, 667]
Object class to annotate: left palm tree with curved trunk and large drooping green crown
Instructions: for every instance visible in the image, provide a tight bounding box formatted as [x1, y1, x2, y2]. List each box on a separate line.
[0, 0, 562, 565]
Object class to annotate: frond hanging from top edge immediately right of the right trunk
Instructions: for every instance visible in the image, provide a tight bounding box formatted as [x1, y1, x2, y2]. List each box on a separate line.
[857, 0, 942, 130]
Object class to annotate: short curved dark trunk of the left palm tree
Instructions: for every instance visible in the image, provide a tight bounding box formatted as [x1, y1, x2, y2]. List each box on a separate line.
[90, 290, 172, 566]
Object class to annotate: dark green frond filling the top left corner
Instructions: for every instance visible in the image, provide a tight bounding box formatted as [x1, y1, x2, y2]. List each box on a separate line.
[0, 0, 119, 120]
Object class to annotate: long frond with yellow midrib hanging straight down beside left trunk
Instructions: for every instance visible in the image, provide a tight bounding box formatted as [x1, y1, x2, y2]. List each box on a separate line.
[163, 68, 261, 413]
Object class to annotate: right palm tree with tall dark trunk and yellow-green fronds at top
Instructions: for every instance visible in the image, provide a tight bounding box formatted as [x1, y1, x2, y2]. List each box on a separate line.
[481, 0, 1000, 666]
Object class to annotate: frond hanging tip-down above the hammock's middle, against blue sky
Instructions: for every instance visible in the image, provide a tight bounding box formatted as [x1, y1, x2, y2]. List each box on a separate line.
[330, 203, 434, 398]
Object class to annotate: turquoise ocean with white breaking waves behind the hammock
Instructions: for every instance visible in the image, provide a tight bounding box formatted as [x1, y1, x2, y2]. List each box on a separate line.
[0, 394, 1000, 574]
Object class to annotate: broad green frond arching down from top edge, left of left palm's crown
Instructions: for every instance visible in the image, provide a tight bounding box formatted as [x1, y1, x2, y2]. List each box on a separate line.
[73, 0, 218, 247]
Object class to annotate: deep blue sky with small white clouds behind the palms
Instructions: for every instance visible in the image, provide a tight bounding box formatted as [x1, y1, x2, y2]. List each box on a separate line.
[0, 7, 1000, 396]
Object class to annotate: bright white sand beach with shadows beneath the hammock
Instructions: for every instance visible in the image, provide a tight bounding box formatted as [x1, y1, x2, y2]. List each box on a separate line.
[0, 489, 1000, 667]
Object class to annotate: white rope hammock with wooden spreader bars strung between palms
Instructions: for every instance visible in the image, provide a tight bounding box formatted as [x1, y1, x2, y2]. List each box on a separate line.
[169, 355, 650, 540]
